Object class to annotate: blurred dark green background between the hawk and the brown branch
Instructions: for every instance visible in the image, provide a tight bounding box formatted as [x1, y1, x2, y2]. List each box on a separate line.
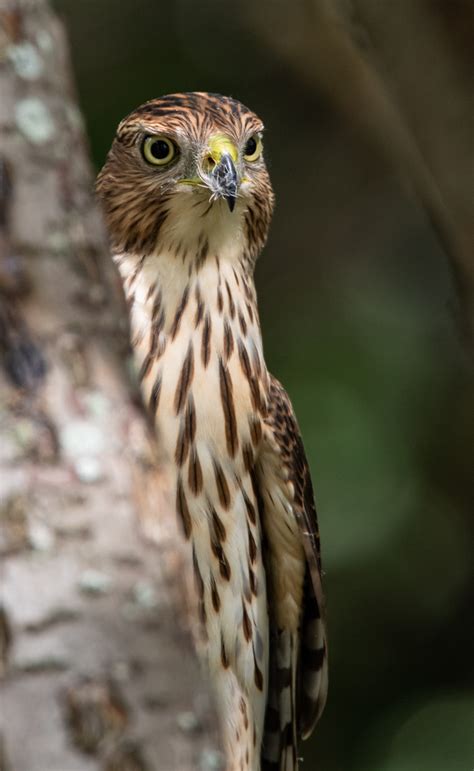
[56, 0, 474, 771]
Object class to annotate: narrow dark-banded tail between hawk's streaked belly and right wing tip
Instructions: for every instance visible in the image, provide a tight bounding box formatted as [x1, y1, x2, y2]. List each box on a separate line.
[261, 629, 298, 771]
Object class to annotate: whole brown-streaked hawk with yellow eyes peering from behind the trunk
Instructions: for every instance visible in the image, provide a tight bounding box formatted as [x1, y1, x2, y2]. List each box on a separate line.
[97, 92, 327, 771]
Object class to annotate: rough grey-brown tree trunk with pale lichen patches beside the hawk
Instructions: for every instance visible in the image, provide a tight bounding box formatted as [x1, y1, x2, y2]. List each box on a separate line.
[0, 0, 219, 771]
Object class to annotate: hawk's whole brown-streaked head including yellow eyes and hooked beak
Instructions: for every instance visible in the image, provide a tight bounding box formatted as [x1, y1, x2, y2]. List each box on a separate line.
[97, 92, 273, 257]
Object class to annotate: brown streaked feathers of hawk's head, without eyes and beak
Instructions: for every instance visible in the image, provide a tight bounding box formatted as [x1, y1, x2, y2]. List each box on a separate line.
[97, 92, 274, 261]
